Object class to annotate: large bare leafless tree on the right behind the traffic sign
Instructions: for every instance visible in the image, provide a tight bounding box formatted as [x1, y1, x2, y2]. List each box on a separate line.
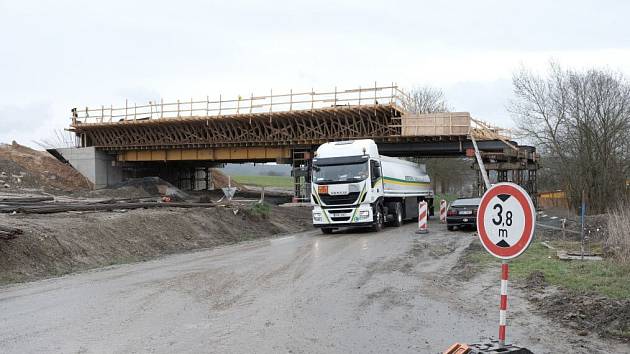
[510, 63, 630, 212]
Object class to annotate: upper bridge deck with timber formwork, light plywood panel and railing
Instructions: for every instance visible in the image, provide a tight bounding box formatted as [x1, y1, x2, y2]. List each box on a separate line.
[70, 85, 508, 151]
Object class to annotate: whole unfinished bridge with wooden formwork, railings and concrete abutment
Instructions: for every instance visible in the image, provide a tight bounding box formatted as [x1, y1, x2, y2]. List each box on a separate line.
[59, 84, 538, 202]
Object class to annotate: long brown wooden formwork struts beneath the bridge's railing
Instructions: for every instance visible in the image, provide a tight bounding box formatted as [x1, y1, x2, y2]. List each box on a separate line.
[73, 104, 401, 150]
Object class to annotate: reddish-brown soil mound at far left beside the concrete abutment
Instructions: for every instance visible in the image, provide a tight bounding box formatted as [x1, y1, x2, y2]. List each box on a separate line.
[0, 142, 92, 192]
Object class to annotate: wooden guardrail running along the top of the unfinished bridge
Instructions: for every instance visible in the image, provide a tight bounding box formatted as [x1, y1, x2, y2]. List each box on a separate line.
[71, 83, 409, 125]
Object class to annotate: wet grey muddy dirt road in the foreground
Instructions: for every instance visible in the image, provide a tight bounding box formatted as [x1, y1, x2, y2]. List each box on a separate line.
[0, 224, 627, 353]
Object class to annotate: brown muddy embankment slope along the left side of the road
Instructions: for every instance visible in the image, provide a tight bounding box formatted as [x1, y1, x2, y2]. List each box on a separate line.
[0, 203, 310, 284]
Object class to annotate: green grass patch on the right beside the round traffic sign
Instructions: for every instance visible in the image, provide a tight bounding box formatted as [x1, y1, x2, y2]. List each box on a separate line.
[467, 242, 630, 299]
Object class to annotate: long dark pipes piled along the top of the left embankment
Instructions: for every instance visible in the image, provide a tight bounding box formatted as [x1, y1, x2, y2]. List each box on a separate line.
[0, 197, 216, 214]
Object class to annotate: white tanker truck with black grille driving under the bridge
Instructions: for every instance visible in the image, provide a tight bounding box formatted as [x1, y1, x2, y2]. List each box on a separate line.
[311, 139, 434, 234]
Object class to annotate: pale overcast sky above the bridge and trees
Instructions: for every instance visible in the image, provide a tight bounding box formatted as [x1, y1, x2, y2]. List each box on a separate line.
[0, 0, 630, 146]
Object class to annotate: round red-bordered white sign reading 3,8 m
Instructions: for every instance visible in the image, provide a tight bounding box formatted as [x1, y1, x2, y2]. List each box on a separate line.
[477, 183, 536, 259]
